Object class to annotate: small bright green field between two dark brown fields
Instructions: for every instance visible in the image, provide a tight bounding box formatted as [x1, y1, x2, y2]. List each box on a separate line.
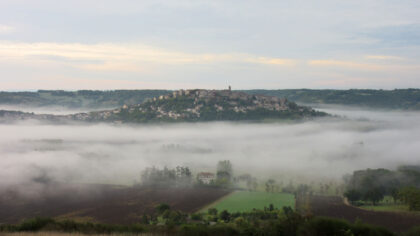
[202, 191, 295, 212]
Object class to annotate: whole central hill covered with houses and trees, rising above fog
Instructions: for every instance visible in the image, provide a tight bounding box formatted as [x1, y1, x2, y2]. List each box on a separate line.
[72, 89, 326, 123]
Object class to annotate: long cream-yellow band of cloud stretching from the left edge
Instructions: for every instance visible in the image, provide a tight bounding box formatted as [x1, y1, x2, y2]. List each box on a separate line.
[0, 42, 295, 72]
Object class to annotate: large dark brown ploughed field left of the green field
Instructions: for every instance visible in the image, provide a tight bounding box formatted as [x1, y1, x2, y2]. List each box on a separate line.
[0, 185, 229, 224]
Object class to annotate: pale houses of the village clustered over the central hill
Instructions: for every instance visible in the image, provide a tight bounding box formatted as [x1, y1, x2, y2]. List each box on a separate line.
[66, 87, 298, 120]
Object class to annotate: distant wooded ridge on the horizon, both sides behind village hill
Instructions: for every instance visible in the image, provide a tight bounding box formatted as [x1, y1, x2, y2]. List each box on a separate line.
[0, 89, 420, 110]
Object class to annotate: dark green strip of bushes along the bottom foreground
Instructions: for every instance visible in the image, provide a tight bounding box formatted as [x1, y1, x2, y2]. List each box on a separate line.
[0, 207, 398, 236]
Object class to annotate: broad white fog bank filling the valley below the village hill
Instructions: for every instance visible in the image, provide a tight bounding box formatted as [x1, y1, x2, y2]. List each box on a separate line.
[0, 108, 420, 189]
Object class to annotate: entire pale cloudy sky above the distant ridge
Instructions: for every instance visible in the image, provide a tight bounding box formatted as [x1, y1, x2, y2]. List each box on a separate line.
[0, 0, 420, 90]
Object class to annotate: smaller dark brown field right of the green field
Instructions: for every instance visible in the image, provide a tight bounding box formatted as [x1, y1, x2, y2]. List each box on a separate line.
[310, 196, 420, 232]
